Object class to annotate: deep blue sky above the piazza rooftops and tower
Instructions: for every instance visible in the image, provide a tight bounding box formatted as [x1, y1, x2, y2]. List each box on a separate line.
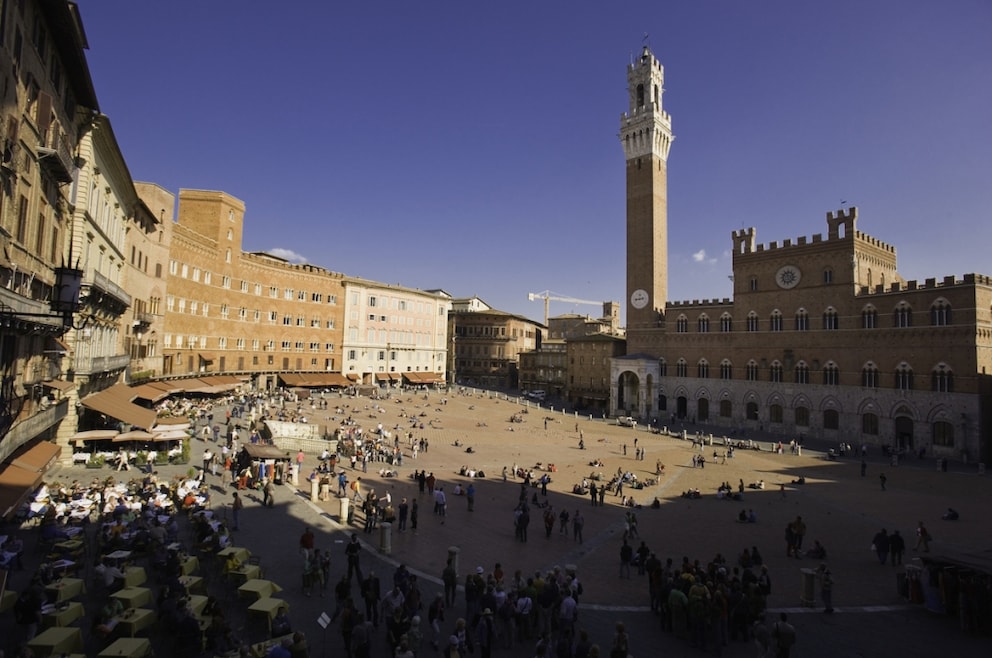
[79, 0, 992, 320]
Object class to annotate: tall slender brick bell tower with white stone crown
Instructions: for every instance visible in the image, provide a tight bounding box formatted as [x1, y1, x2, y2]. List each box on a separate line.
[620, 46, 674, 336]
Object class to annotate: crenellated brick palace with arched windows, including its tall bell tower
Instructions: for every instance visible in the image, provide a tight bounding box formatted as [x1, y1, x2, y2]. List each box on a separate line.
[610, 49, 992, 460]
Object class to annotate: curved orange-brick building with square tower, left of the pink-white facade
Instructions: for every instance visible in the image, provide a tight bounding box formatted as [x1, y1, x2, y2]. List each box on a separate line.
[162, 190, 345, 388]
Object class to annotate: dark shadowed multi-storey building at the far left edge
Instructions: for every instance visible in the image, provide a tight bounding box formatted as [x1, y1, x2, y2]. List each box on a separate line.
[0, 2, 99, 462]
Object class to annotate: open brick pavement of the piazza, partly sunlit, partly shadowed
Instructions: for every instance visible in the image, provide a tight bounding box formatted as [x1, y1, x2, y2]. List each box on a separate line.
[27, 386, 992, 658]
